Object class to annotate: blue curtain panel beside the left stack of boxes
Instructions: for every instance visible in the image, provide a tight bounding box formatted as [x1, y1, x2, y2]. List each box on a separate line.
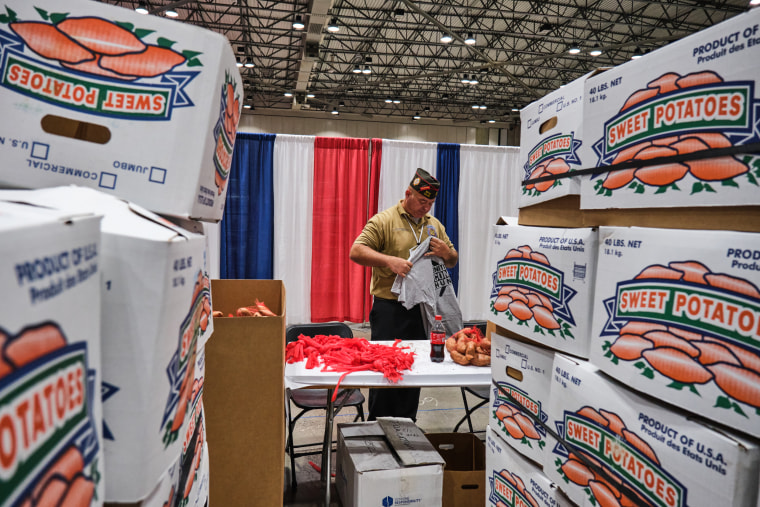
[219, 132, 276, 279]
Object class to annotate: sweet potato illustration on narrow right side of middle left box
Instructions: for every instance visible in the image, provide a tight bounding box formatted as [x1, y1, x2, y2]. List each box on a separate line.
[161, 270, 211, 446]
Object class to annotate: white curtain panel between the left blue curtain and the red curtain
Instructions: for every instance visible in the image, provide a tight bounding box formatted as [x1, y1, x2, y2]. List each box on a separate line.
[273, 134, 314, 325]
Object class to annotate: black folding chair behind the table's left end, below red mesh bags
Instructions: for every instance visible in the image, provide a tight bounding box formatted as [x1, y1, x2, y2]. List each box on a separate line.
[285, 322, 364, 489]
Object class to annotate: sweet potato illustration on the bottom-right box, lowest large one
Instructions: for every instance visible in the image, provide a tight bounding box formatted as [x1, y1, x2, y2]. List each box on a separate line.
[554, 406, 672, 507]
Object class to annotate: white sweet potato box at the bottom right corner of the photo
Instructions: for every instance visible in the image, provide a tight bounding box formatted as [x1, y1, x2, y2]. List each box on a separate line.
[544, 354, 760, 507]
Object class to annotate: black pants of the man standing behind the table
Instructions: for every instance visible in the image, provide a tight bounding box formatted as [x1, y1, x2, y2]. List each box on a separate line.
[367, 298, 428, 421]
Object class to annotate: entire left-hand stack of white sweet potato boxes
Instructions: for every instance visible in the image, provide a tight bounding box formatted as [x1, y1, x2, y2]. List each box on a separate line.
[0, 0, 242, 506]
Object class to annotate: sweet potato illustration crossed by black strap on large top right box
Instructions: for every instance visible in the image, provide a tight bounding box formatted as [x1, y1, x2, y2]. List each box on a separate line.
[594, 71, 760, 197]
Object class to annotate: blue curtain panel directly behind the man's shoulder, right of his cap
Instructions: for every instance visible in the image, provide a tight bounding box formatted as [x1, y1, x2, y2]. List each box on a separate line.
[434, 143, 459, 292]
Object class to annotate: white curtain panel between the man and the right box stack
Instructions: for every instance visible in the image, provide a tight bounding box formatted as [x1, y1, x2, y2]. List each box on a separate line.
[458, 144, 521, 321]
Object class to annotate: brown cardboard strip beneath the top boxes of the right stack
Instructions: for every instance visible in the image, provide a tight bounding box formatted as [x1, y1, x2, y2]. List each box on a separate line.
[518, 195, 760, 232]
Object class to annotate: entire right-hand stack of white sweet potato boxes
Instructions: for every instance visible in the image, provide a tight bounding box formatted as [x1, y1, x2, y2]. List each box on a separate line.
[487, 9, 760, 507]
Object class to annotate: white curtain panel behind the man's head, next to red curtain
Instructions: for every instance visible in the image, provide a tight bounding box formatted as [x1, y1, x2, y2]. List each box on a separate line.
[377, 139, 438, 214]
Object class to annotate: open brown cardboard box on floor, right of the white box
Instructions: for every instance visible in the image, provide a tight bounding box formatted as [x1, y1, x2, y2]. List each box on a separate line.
[425, 433, 486, 507]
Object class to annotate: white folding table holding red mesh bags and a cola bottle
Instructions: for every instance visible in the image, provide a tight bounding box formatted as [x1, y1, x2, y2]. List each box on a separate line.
[285, 340, 491, 507]
